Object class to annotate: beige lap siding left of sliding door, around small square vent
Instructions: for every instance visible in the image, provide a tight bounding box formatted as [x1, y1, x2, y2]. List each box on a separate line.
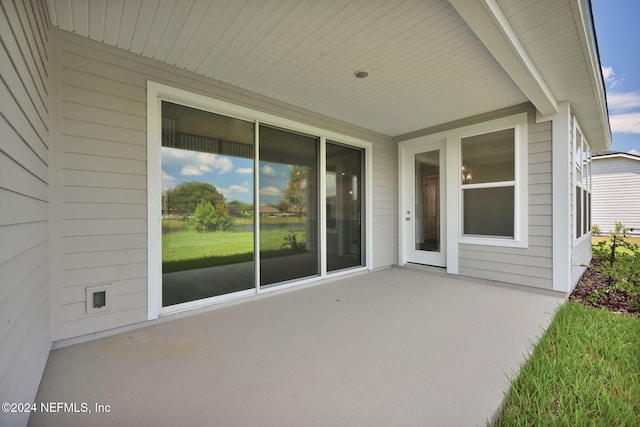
[55, 36, 147, 339]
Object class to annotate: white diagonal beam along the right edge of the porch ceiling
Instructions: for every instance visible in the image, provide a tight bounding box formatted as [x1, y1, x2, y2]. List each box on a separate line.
[449, 0, 558, 116]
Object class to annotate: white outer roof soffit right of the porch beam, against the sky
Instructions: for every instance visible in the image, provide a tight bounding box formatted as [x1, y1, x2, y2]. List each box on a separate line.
[497, 0, 610, 148]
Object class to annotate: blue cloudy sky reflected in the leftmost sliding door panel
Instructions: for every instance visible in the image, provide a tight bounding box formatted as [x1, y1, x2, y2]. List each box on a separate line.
[162, 147, 253, 203]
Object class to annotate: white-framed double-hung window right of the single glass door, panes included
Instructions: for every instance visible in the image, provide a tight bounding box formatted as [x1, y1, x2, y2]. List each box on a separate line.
[456, 113, 528, 247]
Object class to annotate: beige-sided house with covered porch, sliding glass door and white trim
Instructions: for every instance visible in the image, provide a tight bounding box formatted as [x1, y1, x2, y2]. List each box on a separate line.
[0, 0, 610, 424]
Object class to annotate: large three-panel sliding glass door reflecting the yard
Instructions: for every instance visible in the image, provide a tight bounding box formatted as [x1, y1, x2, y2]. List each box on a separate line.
[154, 94, 365, 312]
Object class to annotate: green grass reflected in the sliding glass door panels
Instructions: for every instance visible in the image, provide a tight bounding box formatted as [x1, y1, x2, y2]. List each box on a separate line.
[162, 224, 305, 273]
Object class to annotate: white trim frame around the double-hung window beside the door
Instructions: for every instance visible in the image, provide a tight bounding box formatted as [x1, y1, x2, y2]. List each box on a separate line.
[450, 113, 529, 248]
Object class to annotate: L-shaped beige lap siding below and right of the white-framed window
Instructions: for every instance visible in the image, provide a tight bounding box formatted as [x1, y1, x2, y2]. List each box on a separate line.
[459, 118, 552, 289]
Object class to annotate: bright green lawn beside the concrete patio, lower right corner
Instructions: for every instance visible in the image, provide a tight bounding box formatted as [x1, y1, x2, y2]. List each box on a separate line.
[495, 302, 640, 427]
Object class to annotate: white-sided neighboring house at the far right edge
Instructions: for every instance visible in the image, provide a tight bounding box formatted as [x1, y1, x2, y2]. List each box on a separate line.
[591, 150, 640, 234]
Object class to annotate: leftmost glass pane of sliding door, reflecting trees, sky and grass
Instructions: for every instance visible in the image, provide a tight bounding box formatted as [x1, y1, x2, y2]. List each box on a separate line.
[161, 101, 255, 306]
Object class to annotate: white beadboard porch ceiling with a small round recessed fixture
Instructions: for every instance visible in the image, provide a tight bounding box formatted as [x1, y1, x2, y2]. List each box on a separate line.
[47, 0, 527, 136]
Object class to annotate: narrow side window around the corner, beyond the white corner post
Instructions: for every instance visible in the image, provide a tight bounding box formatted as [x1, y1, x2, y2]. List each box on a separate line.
[573, 118, 591, 240]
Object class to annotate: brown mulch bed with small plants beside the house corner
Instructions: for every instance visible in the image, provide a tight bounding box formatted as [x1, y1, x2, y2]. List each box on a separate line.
[569, 260, 640, 316]
